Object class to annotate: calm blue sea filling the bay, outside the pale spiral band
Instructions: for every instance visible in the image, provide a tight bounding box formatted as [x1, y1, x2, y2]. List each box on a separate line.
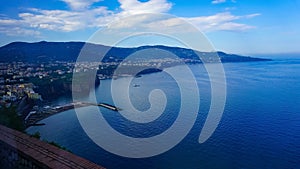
[27, 57, 300, 169]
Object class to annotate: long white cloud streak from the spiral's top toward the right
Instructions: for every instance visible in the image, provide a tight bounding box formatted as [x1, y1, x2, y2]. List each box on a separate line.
[102, 12, 259, 38]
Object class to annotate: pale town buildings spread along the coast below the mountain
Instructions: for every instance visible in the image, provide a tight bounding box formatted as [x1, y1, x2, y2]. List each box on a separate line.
[0, 58, 188, 105]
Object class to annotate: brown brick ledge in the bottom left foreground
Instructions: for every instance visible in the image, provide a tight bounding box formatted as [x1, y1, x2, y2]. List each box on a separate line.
[0, 125, 104, 169]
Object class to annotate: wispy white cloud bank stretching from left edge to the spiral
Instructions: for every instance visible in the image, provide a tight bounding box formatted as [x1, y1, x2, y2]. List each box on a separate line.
[0, 4, 113, 37]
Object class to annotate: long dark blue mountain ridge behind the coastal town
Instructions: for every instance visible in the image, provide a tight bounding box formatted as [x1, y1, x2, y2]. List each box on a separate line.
[0, 41, 268, 63]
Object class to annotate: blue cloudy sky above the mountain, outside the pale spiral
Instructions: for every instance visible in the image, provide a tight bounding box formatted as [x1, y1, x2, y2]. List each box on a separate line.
[0, 0, 300, 54]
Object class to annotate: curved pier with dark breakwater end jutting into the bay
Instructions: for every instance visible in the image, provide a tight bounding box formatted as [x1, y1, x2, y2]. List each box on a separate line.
[25, 102, 121, 128]
